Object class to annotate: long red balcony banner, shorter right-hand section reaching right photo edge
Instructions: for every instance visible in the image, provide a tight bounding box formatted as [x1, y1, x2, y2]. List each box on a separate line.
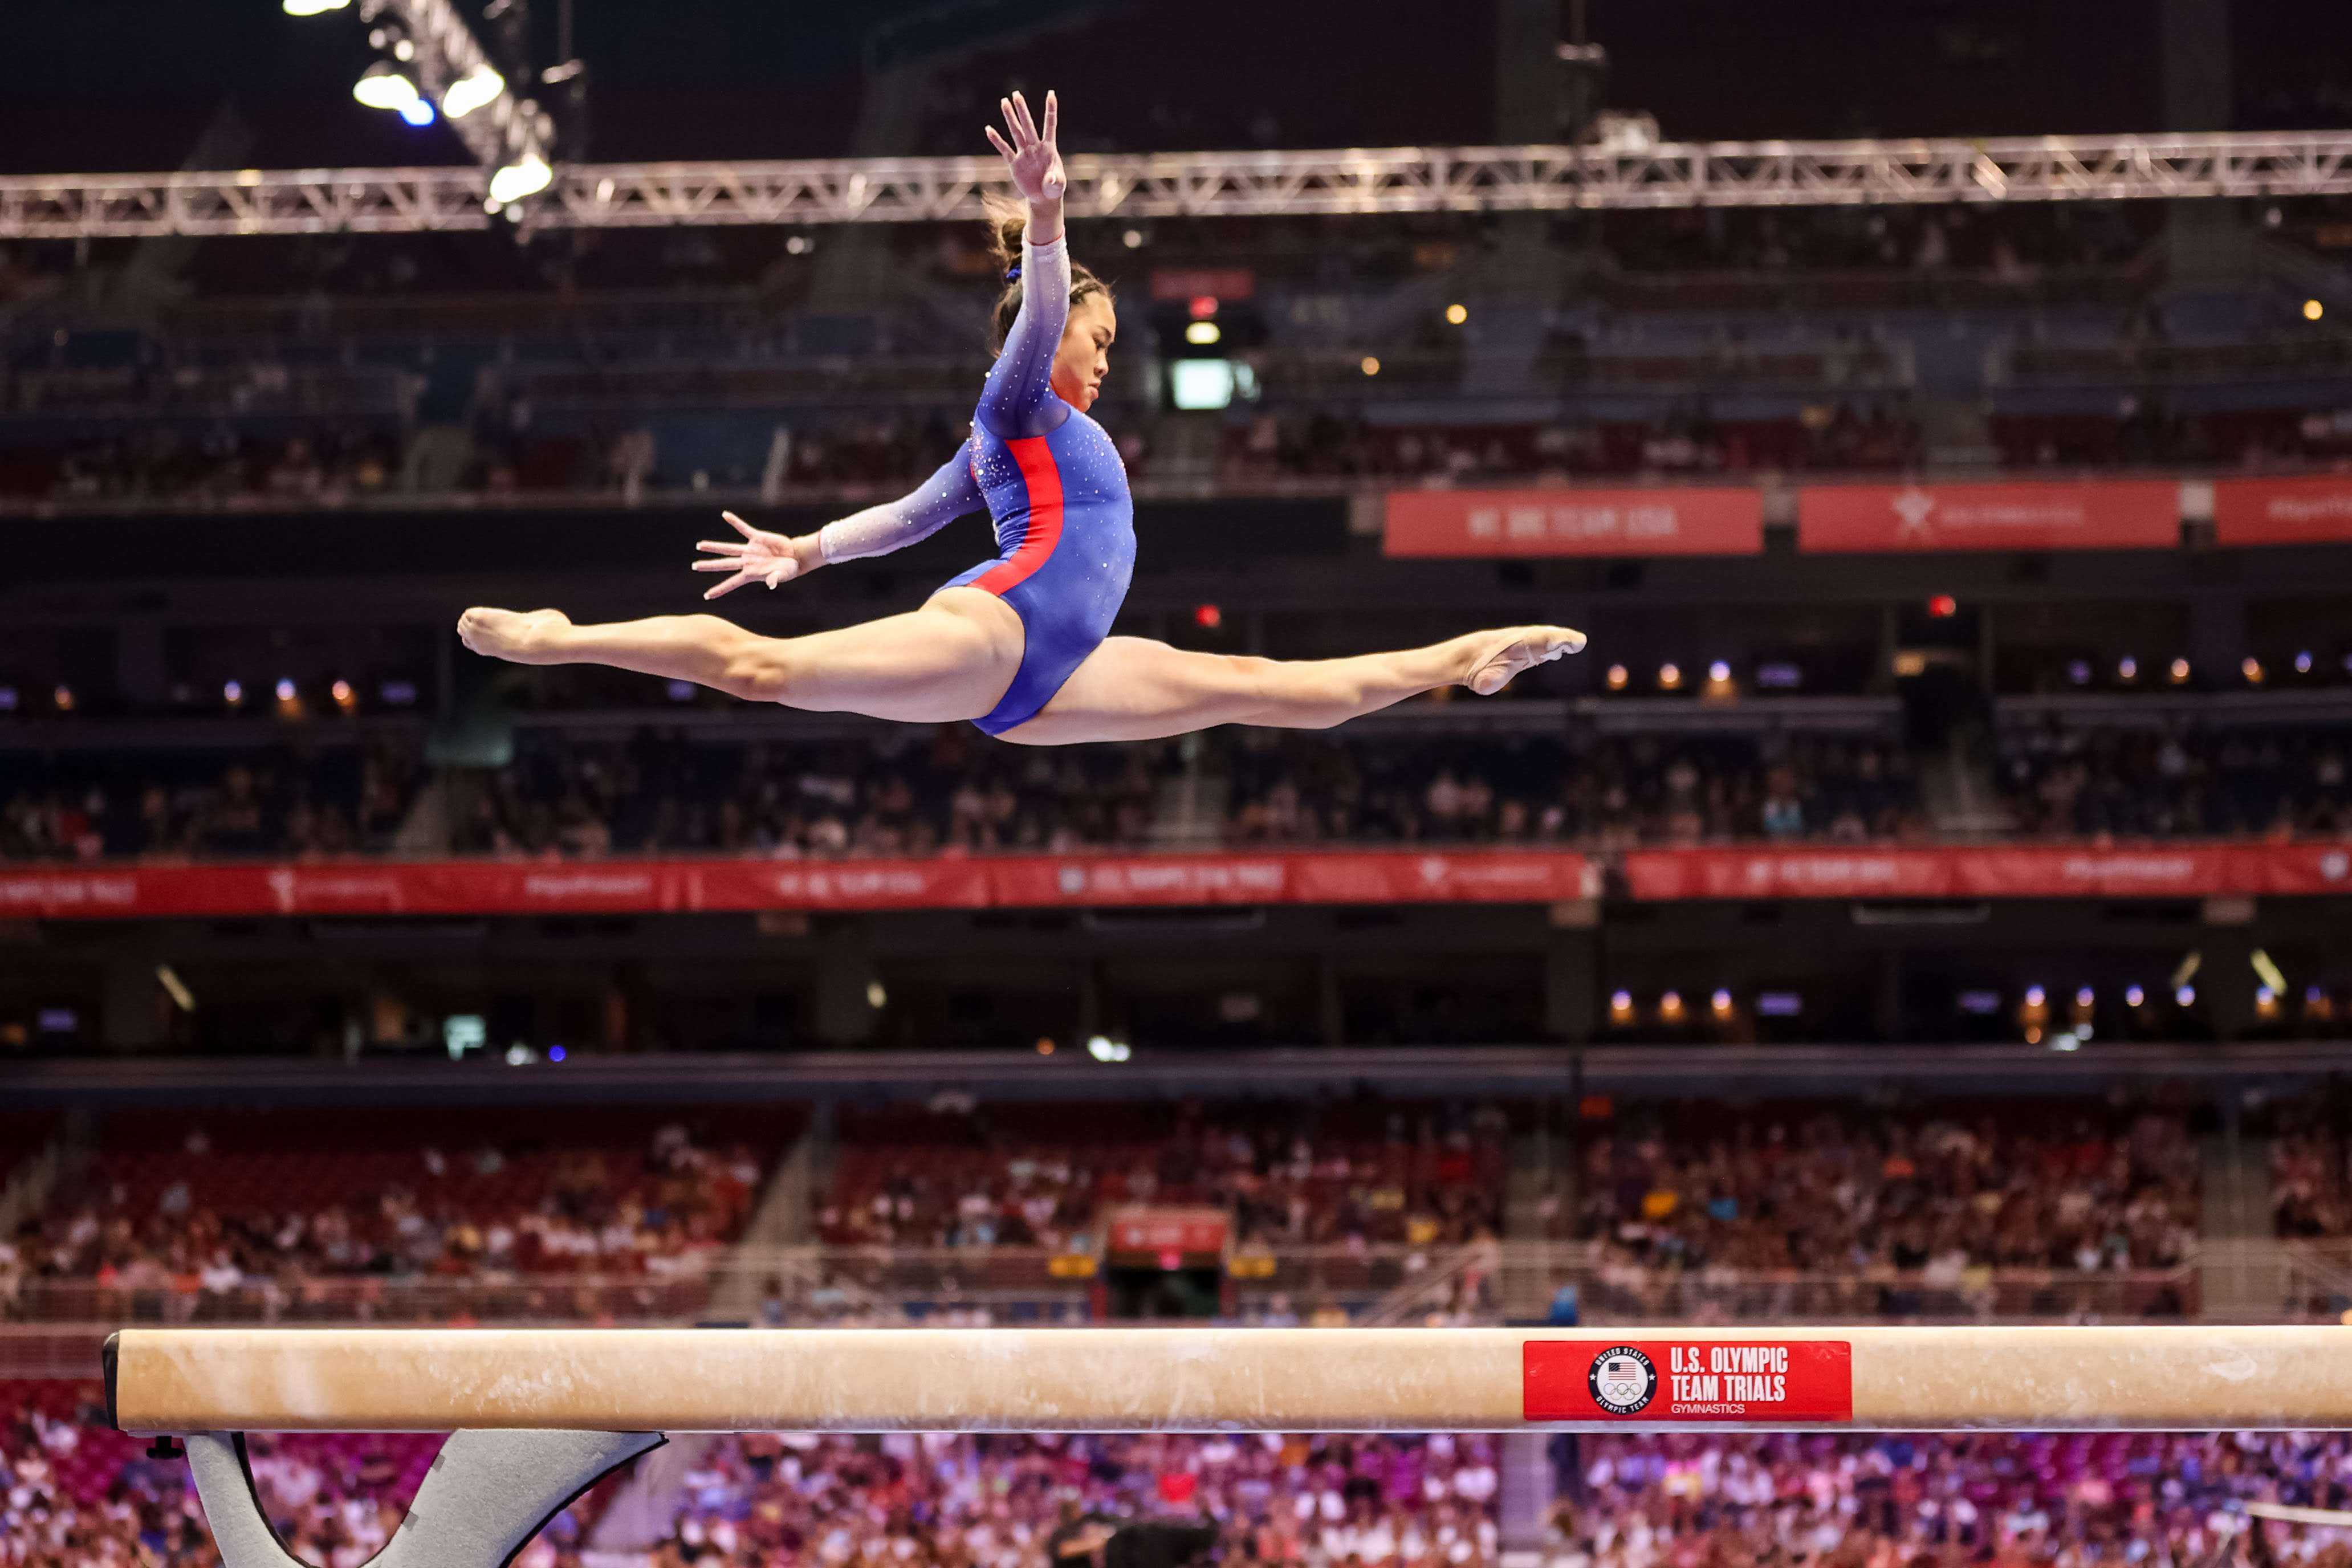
[1625, 844, 2352, 901]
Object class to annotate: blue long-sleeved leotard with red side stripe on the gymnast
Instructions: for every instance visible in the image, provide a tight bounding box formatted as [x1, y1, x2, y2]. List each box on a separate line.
[821, 240, 1136, 736]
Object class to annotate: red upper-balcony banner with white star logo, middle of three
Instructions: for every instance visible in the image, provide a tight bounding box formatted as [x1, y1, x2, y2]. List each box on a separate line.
[1797, 479, 2180, 550]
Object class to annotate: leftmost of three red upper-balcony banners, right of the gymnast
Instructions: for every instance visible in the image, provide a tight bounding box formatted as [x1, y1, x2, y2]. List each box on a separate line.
[1381, 487, 1764, 555]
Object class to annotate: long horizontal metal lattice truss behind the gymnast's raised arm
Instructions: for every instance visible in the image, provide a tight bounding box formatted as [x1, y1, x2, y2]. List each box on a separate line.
[0, 132, 2352, 240]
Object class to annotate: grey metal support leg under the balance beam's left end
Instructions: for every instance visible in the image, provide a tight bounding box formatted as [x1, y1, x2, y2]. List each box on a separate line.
[186, 1432, 668, 1568]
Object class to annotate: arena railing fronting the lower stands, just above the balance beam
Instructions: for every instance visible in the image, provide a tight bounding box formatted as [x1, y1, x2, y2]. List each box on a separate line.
[14, 1239, 2352, 1338]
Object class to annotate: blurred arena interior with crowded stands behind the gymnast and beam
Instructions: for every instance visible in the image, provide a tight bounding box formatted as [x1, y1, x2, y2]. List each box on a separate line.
[0, 0, 2352, 1568]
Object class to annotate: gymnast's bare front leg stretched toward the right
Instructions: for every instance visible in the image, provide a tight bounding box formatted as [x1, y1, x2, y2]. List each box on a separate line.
[1004, 625, 1585, 745]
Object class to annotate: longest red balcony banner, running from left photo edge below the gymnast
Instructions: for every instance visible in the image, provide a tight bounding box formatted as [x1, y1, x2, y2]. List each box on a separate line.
[0, 849, 1600, 919]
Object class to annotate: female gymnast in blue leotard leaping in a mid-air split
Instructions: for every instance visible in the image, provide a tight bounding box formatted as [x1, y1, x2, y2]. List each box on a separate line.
[456, 92, 1585, 745]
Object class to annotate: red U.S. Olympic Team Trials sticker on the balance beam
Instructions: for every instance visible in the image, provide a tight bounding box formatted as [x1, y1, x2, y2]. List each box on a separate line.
[1524, 1340, 1853, 1424]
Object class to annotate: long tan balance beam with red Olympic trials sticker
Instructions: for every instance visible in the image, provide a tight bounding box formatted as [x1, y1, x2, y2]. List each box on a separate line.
[106, 1326, 2352, 1434]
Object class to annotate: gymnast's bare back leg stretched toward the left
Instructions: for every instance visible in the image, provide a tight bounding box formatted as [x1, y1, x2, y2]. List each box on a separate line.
[456, 588, 1023, 724]
